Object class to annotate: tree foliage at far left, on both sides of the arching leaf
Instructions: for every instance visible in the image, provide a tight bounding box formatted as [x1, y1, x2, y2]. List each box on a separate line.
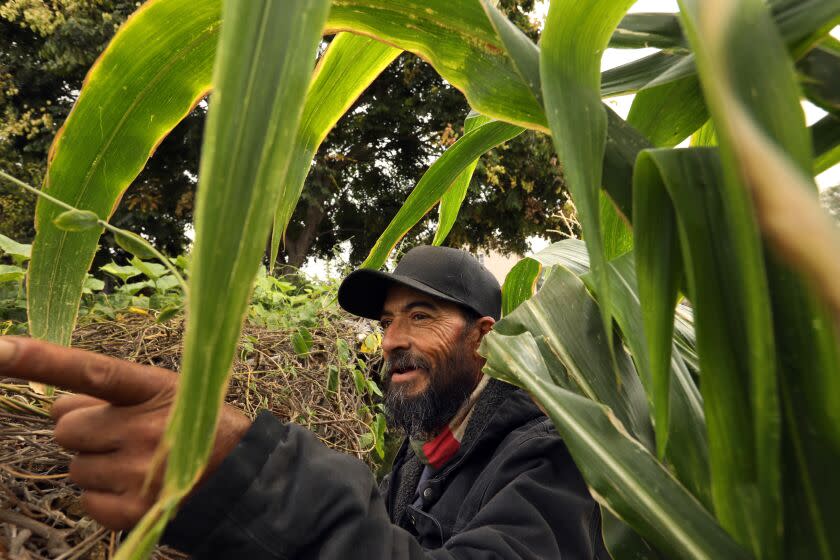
[0, 0, 200, 260]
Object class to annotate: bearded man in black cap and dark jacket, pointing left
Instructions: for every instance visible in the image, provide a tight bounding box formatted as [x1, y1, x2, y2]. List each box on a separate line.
[0, 247, 606, 559]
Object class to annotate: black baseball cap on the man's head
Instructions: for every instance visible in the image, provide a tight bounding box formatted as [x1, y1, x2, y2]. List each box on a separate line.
[338, 245, 502, 321]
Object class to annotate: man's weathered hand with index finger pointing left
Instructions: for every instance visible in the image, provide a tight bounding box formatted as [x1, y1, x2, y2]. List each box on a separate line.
[0, 337, 250, 529]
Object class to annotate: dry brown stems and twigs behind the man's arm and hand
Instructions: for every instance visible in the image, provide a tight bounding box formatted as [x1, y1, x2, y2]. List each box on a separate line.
[0, 316, 377, 560]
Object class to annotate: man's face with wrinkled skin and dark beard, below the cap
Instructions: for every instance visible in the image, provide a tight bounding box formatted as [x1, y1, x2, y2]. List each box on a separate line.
[381, 285, 492, 439]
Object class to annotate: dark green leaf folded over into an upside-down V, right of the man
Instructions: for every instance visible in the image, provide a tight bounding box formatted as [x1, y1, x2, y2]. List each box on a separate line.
[633, 148, 779, 550]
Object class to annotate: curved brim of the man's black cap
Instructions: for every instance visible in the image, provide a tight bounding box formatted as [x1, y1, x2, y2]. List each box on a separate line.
[338, 268, 472, 321]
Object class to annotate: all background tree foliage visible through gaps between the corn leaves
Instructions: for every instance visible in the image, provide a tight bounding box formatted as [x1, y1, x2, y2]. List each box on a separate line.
[0, 0, 570, 266]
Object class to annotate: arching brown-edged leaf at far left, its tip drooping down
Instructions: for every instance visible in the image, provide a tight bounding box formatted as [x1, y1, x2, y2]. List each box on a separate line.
[28, 0, 219, 344]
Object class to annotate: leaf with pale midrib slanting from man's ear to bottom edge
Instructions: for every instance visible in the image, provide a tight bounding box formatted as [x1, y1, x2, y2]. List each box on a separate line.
[481, 332, 749, 559]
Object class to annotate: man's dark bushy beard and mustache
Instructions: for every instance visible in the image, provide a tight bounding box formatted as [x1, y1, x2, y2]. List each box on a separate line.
[384, 344, 476, 440]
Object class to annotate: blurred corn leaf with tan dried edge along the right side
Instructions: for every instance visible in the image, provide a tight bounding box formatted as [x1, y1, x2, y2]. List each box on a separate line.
[682, 0, 840, 558]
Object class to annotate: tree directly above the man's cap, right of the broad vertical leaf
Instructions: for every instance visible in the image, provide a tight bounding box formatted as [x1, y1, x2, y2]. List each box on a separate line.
[285, 0, 578, 266]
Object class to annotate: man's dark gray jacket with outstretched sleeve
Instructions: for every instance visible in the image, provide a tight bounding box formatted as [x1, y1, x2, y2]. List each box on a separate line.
[165, 380, 608, 560]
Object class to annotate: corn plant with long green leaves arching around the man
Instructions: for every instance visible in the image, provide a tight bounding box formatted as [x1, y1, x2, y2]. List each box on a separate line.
[13, 0, 840, 558]
